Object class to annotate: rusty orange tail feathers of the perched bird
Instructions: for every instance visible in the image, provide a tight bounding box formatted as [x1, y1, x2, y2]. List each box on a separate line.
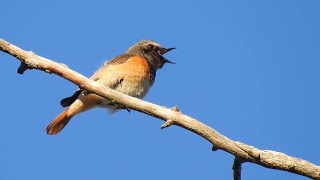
[47, 108, 72, 135]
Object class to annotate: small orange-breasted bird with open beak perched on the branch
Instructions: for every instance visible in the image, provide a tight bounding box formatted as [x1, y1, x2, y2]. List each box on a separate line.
[46, 40, 175, 135]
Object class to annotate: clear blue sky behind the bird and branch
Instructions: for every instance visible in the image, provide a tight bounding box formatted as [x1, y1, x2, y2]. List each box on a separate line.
[0, 0, 320, 180]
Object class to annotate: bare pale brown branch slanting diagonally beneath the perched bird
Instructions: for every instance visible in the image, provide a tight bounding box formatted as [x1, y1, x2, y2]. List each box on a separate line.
[0, 39, 320, 179]
